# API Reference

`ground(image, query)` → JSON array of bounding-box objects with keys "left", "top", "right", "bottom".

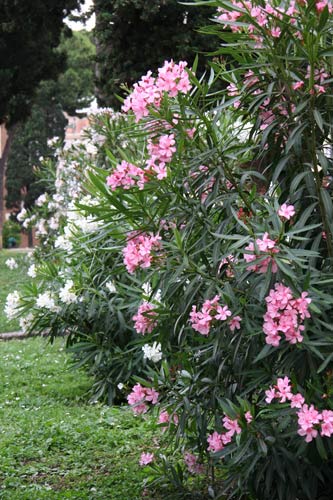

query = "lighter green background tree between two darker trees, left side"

[{"left": 6, "top": 31, "right": 95, "bottom": 208}]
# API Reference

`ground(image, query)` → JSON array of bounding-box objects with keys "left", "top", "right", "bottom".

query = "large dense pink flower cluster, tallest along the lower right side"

[{"left": 263, "top": 283, "right": 311, "bottom": 347}]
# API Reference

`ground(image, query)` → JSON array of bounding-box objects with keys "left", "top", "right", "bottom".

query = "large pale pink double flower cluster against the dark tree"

[{"left": 123, "top": 60, "right": 191, "bottom": 121}]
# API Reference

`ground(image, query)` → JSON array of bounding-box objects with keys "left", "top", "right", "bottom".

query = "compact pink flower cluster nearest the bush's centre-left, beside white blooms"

[{"left": 123, "top": 233, "right": 161, "bottom": 274}]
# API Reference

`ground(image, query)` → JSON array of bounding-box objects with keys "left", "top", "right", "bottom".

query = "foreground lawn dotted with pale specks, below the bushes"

[{"left": 0, "top": 338, "right": 157, "bottom": 500}]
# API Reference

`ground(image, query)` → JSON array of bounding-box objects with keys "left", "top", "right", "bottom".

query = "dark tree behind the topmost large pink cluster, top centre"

[{"left": 94, "top": 0, "right": 215, "bottom": 106}]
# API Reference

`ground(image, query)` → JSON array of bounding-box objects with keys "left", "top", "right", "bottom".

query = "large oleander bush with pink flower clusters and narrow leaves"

[{"left": 5, "top": 0, "right": 333, "bottom": 500}]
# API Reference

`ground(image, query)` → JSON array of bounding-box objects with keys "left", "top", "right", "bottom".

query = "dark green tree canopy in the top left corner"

[{"left": 0, "top": 0, "right": 83, "bottom": 124}]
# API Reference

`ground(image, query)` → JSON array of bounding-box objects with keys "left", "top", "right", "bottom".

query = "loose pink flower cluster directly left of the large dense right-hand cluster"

[{"left": 190, "top": 295, "right": 241, "bottom": 335}]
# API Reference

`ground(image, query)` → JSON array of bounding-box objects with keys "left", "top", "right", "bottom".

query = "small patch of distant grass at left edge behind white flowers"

[{"left": 0, "top": 250, "right": 31, "bottom": 333}]
